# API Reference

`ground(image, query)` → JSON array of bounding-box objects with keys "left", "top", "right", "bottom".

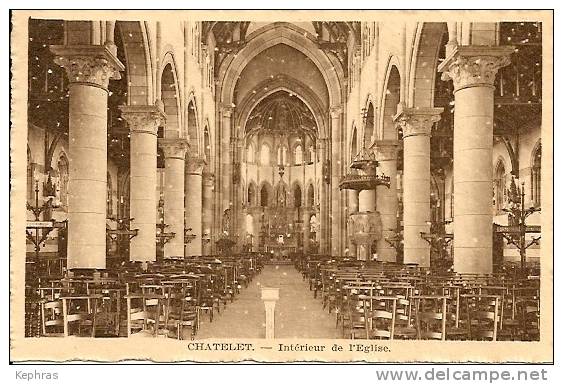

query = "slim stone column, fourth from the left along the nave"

[{"left": 184, "top": 157, "right": 205, "bottom": 257}]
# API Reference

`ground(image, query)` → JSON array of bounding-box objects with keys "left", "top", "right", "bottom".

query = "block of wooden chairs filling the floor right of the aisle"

[{"left": 298, "top": 257, "right": 540, "bottom": 340}]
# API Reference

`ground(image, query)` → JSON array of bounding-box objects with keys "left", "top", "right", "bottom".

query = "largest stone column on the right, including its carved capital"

[{"left": 439, "top": 46, "right": 514, "bottom": 273}]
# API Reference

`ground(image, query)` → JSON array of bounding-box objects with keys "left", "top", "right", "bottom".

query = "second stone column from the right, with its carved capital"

[{"left": 394, "top": 104, "right": 443, "bottom": 267}]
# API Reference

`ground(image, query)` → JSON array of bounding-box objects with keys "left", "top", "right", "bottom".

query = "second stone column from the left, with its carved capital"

[{"left": 120, "top": 105, "right": 165, "bottom": 262}]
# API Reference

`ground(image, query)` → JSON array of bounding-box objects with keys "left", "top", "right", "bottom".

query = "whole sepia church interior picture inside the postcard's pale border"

[{"left": 20, "top": 12, "right": 552, "bottom": 343}]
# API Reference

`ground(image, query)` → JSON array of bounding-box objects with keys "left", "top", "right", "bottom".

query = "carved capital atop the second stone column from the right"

[{"left": 393, "top": 104, "right": 444, "bottom": 138}]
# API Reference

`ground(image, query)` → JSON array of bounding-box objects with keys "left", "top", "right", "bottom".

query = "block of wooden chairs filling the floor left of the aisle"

[{"left": 32, "top": 255, "right": 262, "bottom": 339}]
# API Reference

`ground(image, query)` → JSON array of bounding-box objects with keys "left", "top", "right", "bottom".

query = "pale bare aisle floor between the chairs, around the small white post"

[{"left": 196, "top": 265, "right": 341, "bottom": 339}]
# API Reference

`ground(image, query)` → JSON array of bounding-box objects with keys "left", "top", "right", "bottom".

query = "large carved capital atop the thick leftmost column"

[{"left": 50, "top": 45, "right": 125, "bottom": 91}]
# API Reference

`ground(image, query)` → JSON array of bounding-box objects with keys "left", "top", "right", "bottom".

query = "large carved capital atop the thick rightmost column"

[{"left": 438, "top": 45, "right": 514, "bottom": 92}]
